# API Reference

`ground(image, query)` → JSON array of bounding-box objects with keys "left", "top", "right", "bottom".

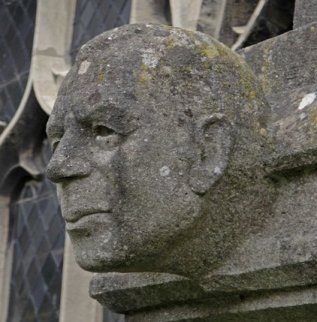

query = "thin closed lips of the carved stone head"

[{"left": 66, "top": 212, "right": 112, "bottom": 231}]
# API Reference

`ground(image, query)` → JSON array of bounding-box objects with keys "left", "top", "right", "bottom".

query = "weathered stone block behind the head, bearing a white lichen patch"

[{"left": 242, "top": 23, "right": 317, "bottom": 171}]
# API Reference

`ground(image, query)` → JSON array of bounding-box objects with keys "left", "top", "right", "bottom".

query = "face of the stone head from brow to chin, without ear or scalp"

[{"left": 48, "top": 78, "right": 200, "bottom": 269}]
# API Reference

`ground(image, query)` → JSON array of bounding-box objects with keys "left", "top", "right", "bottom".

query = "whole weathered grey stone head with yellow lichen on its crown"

[{"left": 47, "top": 25, "right": 271, "bottom": 277}]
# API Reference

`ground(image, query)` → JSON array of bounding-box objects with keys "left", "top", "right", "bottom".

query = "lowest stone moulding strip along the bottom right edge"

[{"left": 126, "top": 288, "right": 317, "bottom": 322}]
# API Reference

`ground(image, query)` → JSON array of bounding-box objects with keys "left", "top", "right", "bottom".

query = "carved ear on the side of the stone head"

[{"left": 189, "top": 113, "right": 233, "bottom": 195}]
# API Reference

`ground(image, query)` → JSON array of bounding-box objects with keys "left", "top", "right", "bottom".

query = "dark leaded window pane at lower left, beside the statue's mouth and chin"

[{"left": 7, "top": 178, "right": 65, "bottom": 322}]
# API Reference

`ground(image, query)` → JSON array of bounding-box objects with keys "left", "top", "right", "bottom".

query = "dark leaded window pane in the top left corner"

[{"left": 0, "top": 0, "right": 36, "bottom": 123}]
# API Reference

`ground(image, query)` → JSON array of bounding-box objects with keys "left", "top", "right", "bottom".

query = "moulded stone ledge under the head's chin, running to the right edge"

[{"left": 90, "top": 273, "right": 317, "bottom": 322}]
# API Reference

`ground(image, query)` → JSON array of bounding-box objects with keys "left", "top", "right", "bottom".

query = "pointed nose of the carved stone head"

[{"left": 46, "top": 139, "right": 91, "bottom": 183}]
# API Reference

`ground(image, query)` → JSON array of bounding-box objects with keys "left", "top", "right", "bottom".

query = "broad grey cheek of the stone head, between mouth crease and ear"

[{"left": 122, "top": 138, "right": 198, "bottom": 231}]
